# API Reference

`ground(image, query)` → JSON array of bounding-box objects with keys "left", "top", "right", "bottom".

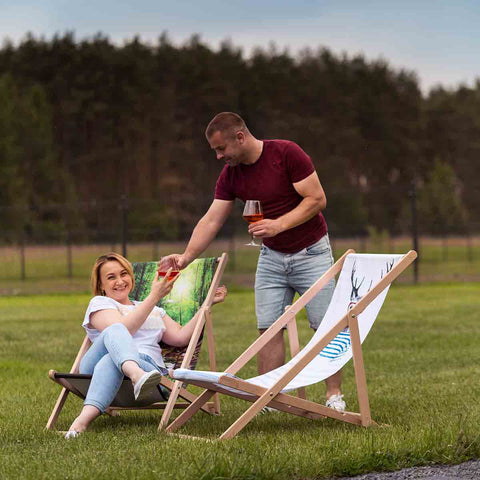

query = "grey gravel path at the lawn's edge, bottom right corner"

[{"left": 336, "top": 460, "right": 480, "bottom": 480}]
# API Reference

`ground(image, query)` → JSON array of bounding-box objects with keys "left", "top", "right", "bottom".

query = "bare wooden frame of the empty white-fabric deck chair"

[{"left": 166, "top": 250, "right": 417, "bottom": 440}]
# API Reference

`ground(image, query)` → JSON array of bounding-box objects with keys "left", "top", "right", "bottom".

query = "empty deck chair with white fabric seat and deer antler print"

[{"left": 166, "top": 250, "right": 417, "bottom": 440}]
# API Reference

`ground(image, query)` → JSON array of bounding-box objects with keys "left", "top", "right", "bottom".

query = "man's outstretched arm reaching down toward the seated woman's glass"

[{"left": 158, "top": 199, "right": 233, "bottom": 270}]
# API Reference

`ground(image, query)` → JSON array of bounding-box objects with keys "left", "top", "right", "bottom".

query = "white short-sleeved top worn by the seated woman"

[{"left": 82, "top": 295, "right": 166, "bottom": 367}]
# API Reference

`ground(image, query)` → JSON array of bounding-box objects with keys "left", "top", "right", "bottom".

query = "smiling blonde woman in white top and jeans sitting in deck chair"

[{"left": 65, "top": 253, "right": 227, "bottom": 438}]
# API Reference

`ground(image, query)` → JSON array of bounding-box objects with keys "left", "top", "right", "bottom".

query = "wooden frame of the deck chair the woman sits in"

[{"left": 46, "top": 253, "right": 228, "bottom": 430}]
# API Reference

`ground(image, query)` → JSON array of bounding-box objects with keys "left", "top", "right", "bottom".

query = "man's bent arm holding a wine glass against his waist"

[{"left": 248, "top": 172, "right": 327, "bottom": 238}]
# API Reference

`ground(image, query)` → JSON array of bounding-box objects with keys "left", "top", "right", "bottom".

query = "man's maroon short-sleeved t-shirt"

[{"left": 215, "top": 140, "right": 327, "bottom": 253}]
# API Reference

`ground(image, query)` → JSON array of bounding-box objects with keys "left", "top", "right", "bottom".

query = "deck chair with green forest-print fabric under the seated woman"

[{"left": 46, "top": 253, "right": 228, "bottom": 429}]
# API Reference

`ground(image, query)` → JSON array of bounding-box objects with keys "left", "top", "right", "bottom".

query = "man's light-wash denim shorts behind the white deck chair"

[{"left": 255, "top": 234, "right": 335, "bottom": 330}]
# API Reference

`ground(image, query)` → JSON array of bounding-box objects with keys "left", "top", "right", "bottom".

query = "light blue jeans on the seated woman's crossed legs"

[{"left": 80, "top": 323, "right": 160, "bottom": 413}]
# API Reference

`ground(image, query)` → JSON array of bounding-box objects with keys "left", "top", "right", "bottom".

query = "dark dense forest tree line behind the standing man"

[{"left": 0, "top": 33, "right": 480, "bottom": 241}]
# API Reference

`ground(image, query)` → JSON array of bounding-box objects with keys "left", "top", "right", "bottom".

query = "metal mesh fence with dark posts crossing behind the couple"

[{"left": 0, "top": 197, "right": 480, "bottom": 292}]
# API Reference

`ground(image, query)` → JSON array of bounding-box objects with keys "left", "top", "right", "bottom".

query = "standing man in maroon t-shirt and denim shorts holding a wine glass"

[{"left": 159, "top": 112, "right": 345, "bottom": 411}]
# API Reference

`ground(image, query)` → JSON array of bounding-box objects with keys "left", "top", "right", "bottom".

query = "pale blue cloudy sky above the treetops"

[{"left": 0, "top": 0, "right": 480, "bottom": 93}]
